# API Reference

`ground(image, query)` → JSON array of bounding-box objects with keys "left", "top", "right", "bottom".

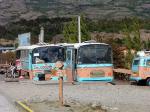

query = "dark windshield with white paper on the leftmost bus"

[{"left": 32, "top": 46, "right": 64, "bottom": 64}]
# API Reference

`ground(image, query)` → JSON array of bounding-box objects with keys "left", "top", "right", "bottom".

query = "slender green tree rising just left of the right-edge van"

[{"left": 123, "top": 18, "right": 143, "bottom": 69}]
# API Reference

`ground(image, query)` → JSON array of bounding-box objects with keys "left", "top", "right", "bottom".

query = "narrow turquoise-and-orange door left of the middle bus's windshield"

[{"left": 66, "top": 48, "right": 76, "bottom": 82}]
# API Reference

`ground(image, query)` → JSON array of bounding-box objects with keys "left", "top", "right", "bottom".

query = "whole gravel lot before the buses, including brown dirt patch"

[{"left": 0, "top": 74, "right": 150, "bottom": 112}]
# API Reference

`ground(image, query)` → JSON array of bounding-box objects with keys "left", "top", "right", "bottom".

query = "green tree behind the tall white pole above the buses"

[{"left": 63, "top": 16, "right": 90, "bottom": 43}]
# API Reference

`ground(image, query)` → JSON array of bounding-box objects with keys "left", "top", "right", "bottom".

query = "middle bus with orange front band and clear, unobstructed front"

[{"left": 63, "top": 42, "right": 113, "bottom": 82}]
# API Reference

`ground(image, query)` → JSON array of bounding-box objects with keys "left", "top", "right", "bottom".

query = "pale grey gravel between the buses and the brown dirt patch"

[{"left": 0, "top": 75, "right": 150, "bottom": 112}]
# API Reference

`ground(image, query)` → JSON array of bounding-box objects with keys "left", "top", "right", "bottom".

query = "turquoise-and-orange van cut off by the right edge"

[{"left": 130, "top": 51, "right": 150, "bottom": 86}]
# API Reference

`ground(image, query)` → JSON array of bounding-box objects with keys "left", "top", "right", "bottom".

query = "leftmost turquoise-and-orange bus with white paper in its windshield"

[{"left": 16, "top": 44, "right": 65, "bottom": 80}]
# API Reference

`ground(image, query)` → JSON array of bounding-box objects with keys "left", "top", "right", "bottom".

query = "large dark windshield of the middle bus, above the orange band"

[{"left": 78, "top": 44, "right": 112, "bottom": 64}]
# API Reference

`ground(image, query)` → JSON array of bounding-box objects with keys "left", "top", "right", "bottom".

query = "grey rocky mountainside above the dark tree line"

[{"left": 0, "top": 0, "right": 150, "bottom": 25}]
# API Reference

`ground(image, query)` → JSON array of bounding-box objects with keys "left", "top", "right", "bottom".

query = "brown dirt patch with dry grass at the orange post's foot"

[{"left": 27, "top": 101, "right": 107, "bottom": 112}]
